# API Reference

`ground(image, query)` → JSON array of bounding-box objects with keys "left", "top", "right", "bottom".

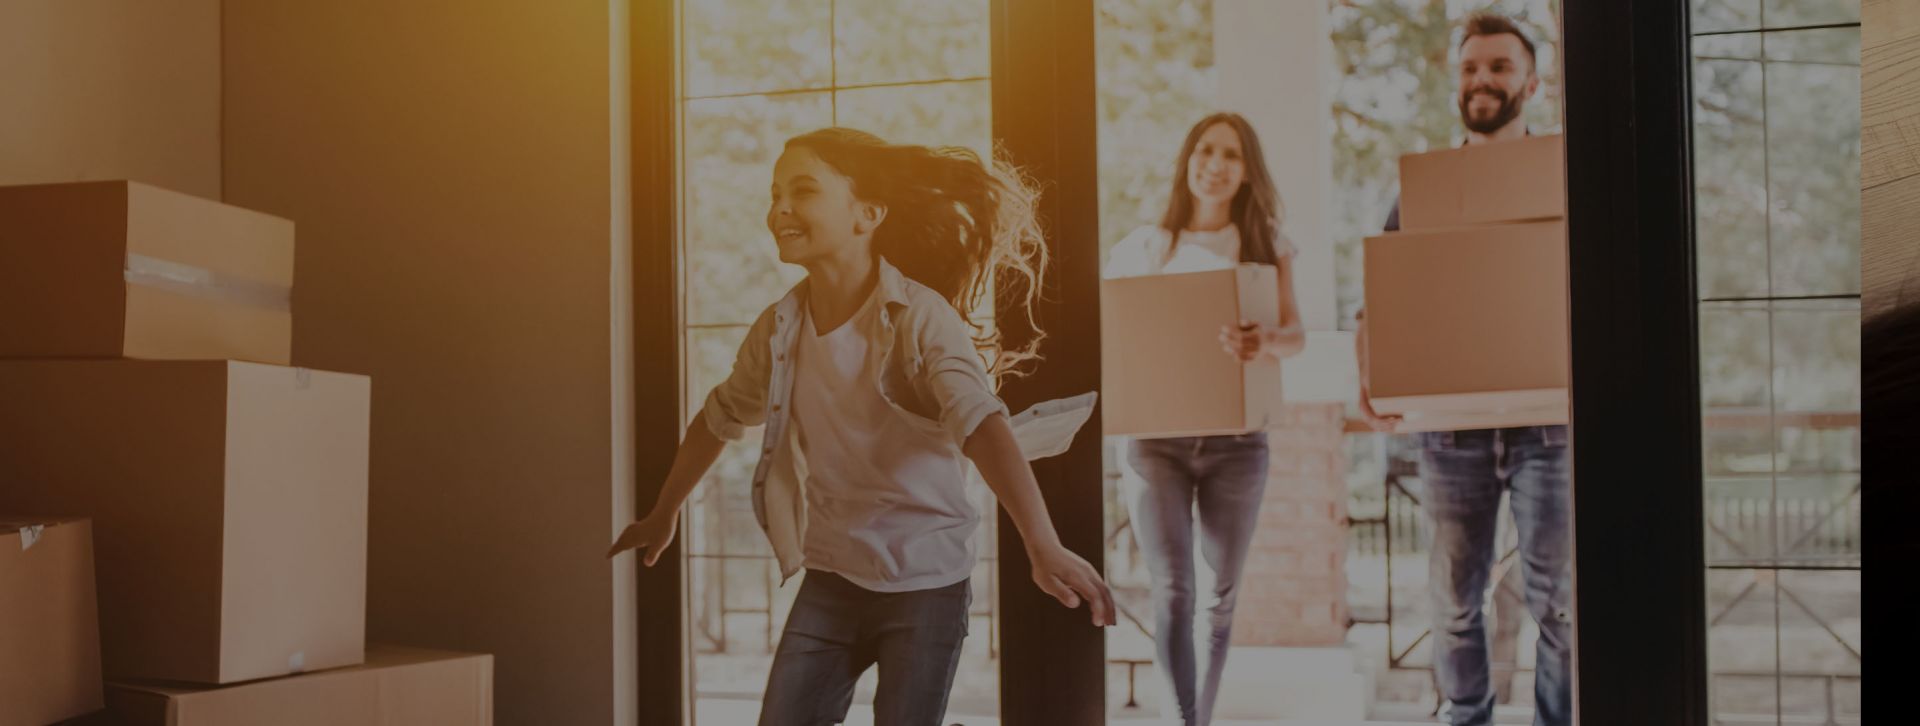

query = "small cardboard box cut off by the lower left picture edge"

[{"left": 0, "top": 514, "right": 102, "bottom": 726}]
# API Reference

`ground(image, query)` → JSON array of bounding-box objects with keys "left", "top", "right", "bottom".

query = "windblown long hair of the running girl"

[{"left": 787, "top": 127, "right": 1046, "bottom": 380}]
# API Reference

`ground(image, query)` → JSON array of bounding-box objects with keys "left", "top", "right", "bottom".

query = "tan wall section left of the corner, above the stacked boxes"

[{"left": 0, "top": 0, "right": 221, "bottom": 200}]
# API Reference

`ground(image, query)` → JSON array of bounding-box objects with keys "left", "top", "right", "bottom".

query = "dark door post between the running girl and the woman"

[{"left": 993, "top": 0, "right": 1106, "bottom": 726}]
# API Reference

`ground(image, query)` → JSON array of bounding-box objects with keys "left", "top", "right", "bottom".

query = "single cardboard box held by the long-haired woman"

[{"left": 1100, "top": 265, "right": 1281, "bottom": 438}]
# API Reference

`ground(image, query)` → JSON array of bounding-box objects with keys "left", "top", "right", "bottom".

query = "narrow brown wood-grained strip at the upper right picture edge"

[{"left": 1860, "top": 0, "right": 1920, "bottom": 315}]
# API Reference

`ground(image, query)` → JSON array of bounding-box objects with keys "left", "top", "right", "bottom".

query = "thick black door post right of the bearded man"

[{"left": 1563, "top": 0, "right": 1707, "bottom": 726}]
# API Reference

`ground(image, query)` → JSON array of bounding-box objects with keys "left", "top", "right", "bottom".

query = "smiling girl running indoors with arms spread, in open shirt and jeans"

[{"left": 614, "top": 129, "right": 1114, "bottom": 726}]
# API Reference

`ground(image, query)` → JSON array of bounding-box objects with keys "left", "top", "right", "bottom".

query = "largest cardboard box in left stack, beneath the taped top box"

[{"left": 0, "top": 359, "right": 371, "bottom": 684}]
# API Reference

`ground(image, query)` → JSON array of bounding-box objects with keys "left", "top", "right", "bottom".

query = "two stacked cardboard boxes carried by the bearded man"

[{"left": 1365, "top": 136, "right": 1569, "bottom": 430}]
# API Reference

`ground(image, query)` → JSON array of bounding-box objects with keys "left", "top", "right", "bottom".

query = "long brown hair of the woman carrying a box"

[{"left": 1160, "top": 111, "right": 1284, "bottom": 265}]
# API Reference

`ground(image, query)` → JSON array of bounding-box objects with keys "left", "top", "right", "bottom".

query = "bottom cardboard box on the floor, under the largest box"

[{"left": 108, "top": 645, "right": 493, "bottom": 726}]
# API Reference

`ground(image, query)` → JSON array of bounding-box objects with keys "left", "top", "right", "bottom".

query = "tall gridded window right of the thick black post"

[{"left": 1693, "top": 9, "right": 1860, "bottom": 724}]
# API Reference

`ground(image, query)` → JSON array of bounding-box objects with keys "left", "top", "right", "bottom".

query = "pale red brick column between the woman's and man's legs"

[{"left": 1233, "top": 403, "right": 1348, "bottom": 647}]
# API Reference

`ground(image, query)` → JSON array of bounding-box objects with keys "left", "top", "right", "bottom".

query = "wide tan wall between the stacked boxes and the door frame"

[{"left": 223, "top": 0, "right": 629, "bottom": 724}]
